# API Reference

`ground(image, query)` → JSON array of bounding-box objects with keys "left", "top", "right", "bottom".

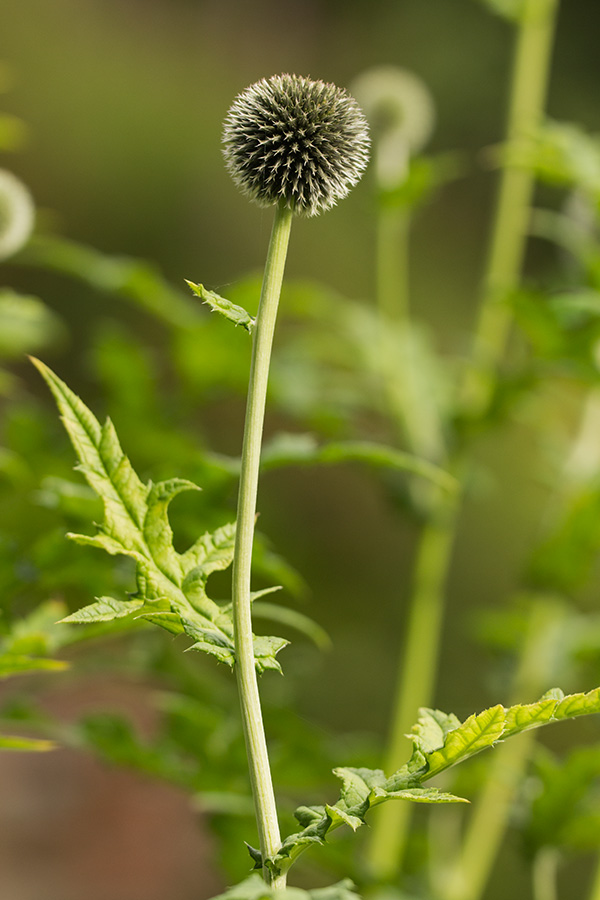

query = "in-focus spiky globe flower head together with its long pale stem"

[{"left": 223, "top": 75, "right": 369, "bottom": 886}]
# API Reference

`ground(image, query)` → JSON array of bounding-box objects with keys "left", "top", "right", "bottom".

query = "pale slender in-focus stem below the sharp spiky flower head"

[{"left": 233, "top": 206, "right": 292, "bottom": 887}]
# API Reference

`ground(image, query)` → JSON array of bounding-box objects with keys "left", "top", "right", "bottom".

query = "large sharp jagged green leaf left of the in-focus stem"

[{"left": 34, "top": 360, "right": 288, "bottom": 672}]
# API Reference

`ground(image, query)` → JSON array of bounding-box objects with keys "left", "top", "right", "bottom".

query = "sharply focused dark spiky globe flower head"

[{"left": 223, "top": 75, "right": 370, "bottom": 216}]
